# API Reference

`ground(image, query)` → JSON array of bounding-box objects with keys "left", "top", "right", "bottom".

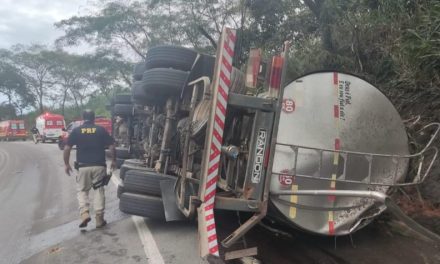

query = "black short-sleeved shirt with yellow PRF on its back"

[{"left": 67, "top": 122, "right": 114, "bottom": 166}]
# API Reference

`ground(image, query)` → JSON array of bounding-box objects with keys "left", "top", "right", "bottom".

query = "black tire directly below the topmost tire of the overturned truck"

[{"left": 142, "top": 68, "right": 189, "bottom": 96}]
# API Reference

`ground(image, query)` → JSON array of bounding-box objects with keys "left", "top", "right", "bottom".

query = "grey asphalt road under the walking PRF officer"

[{"left": 0, "top": 141, "right": 201, "bottom": 264}]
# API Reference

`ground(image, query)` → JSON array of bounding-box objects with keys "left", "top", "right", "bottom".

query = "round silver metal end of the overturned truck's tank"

[{"left": 270, "top": 72, "right": 409, "bottom": 235}]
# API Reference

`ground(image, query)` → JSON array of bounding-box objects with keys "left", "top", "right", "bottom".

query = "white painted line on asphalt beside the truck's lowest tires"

[{"left": 111, "top": 173, "right": 165, "bottom": 264}]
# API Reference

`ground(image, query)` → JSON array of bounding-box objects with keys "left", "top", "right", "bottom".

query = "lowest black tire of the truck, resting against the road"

[{"left": 119, "top": 192, "right": 165, "bottom": 220}]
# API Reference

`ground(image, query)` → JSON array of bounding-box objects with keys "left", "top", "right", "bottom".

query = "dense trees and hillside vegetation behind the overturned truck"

[{"left": 0, "top": 0, "right": 440, "bottom": 122}]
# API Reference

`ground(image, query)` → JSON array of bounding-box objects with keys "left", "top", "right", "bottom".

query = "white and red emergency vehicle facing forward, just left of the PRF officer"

[{"left": 35, "top": 112, "right": 66, "bottom": 143}]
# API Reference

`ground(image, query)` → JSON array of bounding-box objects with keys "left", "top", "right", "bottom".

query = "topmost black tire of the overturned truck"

[{"left": 145, "top": 46, "right": 197, "bottom": 71}]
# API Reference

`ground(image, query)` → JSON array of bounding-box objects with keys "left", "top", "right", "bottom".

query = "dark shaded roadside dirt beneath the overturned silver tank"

[{"left": 217, "top": 211, "right": 440, "bottom": 264}]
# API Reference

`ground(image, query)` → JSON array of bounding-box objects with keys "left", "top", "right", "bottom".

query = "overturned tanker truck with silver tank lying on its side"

[{"left": 112, "top": 28, "right": 439, "bottom": 256}]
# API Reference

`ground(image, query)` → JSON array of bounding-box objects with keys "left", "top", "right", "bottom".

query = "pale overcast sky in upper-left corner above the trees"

[{"left": 0, "top": 0, "right": 90, "bottom": 48}]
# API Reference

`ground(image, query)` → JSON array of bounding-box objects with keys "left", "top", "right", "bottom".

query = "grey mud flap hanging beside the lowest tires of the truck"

[{"left": 159, "top": 180, "right": 186, "bottom": 222}]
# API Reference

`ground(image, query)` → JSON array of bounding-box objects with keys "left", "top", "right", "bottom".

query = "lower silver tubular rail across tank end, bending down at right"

[{"left": 270, "top": 190, "right": 440, "bottom": 244}]
